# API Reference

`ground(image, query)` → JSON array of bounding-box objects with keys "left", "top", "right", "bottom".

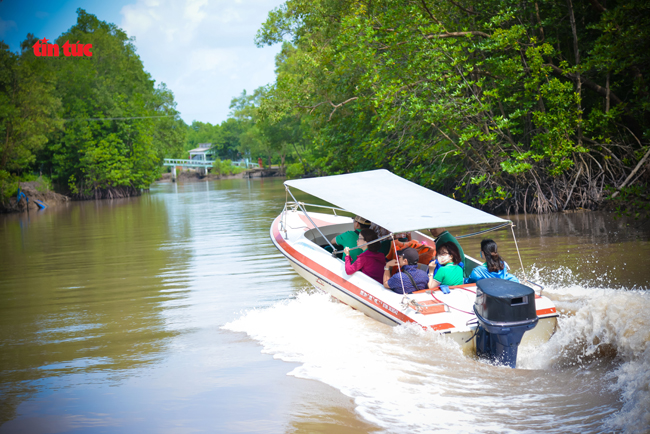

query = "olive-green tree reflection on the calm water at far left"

[{"left": 0, "top": 197, "right": 184, "bottom": 421}]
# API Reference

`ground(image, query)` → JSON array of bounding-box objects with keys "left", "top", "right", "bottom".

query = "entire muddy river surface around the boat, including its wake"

[{"left": 0, "top": 179, "right": 650, "bottom": 434}]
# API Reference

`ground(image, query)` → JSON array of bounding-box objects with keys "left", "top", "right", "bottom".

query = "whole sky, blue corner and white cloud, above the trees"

[{"left": 0, "top": 0, "right": 284, "bottom": 124}]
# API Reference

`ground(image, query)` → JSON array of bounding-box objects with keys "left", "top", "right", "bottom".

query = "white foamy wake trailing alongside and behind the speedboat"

[{"left": 223, "top": 276, "right": 650, "bottom": 433}]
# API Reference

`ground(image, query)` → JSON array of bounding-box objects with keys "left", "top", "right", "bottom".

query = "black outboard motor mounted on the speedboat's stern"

[{"left": 474, "top": 279, "right": 538, "bottom": 368}]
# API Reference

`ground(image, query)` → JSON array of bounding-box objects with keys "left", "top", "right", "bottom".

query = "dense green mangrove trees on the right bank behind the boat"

[{"left": 239, "top": 0, "right": 650, "bottom": 219}]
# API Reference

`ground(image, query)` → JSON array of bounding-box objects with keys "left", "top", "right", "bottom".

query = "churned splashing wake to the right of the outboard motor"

[{"left": 529, "top": 269, "right": 650, "bottom": 433}]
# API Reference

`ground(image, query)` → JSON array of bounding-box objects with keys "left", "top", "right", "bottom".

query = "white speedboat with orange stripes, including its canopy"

[{"left": 270, "top": 170, "right": 558, "bottom": 367}]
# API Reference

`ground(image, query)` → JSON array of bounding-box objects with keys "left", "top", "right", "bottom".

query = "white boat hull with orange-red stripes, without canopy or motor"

[{"left": 270, "top": 210, "right": 558, "bottom": 354}]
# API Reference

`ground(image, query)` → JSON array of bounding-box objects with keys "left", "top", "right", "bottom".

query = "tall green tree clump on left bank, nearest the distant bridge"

[{"left": 43, "top": 9, "right": 186, "bottom": 197}]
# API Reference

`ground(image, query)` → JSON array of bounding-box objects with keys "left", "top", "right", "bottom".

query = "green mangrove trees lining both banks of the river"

[{"left": 0, "top": 0, "right": 650, "bottom": 217}]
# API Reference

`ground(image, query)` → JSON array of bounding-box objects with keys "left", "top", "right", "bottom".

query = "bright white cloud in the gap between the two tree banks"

[{"left": 121, "top": 0, "right": 283, "bottom": 124}]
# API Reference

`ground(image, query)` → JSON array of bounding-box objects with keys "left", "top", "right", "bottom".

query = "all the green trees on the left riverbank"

[{"left": 0, "top": 9, "right": 187, "bottom": 201}]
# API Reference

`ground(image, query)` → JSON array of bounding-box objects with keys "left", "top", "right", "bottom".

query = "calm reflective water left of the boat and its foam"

[{"left": 0, "top": 180, "right": 360, "bottom": 433}]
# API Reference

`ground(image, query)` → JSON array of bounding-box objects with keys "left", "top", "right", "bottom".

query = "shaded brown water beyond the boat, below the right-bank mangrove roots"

[{"left": 450, "top": 212, "right": 650, "bottom": 289}]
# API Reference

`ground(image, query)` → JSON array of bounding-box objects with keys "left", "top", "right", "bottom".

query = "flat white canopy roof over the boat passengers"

[{"left": 284, "top": 169, "right": 510, "bottom": 233}]
